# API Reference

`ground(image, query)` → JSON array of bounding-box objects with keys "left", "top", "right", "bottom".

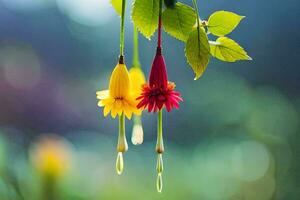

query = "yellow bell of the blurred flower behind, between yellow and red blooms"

[{"left": 129, "top": 67, "right": 146, "bottom": 98}]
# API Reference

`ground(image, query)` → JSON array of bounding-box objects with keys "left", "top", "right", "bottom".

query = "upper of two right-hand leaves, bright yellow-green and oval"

[{"left": 208, "top": 11, "right": 244, "bottom": 36}]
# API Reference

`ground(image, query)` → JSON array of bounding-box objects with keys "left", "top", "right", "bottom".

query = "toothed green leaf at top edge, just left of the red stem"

[{"left": 132, "top": 0, "right": 159, "bottom": 39}]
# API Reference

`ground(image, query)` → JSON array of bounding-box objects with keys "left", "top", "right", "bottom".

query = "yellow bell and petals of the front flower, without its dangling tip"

[{"left": 96, "top": 64, "right": 141, "bottom": 119}]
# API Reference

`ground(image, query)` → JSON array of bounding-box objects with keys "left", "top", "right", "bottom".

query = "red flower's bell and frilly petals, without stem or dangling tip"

[{"left": 137, "top": 47, "right": 183, "bottom": 112}]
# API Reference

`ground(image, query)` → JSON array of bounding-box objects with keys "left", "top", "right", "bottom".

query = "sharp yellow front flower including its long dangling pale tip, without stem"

[{"left": 96, "top": 55, "right": 142, "bottom": 175}]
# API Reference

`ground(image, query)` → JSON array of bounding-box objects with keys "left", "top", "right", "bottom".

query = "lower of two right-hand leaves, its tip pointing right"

[{"left": 210, "top": 37, "right": 252, "bottom": 62}]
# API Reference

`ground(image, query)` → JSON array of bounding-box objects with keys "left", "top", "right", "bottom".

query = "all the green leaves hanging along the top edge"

[{"left": 111, "top": 0, "right": 251, "bottom": 79}]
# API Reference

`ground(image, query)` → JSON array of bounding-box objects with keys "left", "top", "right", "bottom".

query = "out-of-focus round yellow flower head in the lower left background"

[{"left": 30, "top": 136, "right": 71, "bottom": 177}]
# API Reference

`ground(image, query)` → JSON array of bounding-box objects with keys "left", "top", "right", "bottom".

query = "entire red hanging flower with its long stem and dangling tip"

[{"left": 137, "top": 0, "right": 183, "bottom": 193}]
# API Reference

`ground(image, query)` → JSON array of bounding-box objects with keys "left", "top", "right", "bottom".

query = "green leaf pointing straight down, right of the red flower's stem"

[{"left": 185, "top": 28, "right": 210, "bottom": 80}]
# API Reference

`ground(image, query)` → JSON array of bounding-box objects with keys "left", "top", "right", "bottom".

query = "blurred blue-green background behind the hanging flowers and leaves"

[{"left": 0, "top": 0, "right": 300, "bottom": 200}]
